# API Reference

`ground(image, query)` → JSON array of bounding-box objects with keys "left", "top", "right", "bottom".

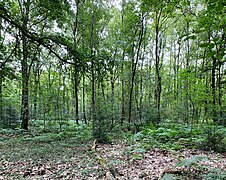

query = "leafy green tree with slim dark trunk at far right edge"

[{"left": 198, "top": 0, "right": 225, "bottom": 123}]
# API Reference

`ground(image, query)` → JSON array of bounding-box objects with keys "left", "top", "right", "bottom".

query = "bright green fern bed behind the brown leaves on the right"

[{"left": 129, "top": 123, "right": 226, "bottom": 152}]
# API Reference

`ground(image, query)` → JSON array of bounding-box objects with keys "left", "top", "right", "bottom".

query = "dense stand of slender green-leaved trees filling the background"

[{"left": 0, "top": 0, "right": 225, "bottom": 136}]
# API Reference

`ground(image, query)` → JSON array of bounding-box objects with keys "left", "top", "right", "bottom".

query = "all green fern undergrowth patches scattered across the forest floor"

[{"left": 0, "top": 121, "right": 226, "bottom": 179}]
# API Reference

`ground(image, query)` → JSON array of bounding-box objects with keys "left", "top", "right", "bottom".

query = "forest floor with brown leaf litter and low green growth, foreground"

[{"left": 0, "top": 126, "right": 226, "bottom": 180}]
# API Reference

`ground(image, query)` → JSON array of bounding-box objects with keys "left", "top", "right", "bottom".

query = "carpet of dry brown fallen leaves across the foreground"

[{"left": 0, "top": 142, "right": 226, "bottom": 180}]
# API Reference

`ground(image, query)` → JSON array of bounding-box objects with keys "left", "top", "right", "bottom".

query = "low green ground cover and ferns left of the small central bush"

[{"left": 0, "top": 124, "right": 92, "bottom": 161}]
